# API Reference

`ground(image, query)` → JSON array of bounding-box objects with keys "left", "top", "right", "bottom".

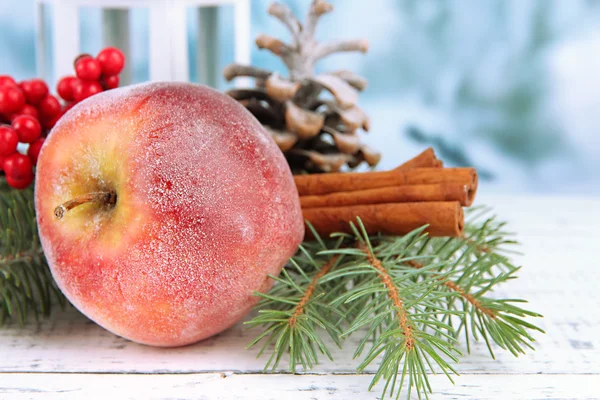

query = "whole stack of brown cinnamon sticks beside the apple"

[{"left": 294, "top": 148, "right": 478, "bottom": 239}]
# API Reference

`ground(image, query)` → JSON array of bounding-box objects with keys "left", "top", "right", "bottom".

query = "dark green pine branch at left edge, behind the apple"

[{"left": 0, "top": 177, "right": 65, "bottom": 325}]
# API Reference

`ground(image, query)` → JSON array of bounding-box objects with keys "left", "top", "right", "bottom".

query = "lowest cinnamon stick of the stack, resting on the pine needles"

[{"left": 302, "top": 201, "right": 464, "bottom": 239}]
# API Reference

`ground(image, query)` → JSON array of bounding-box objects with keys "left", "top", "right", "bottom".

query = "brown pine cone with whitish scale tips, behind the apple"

[{"left": 223, "top": 0, "right": 381, "bottom": 174}]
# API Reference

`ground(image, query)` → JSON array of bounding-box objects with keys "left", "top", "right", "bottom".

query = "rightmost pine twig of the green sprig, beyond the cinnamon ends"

[{"left": 398, "top": 209, "right": 543, "bottom": 358}]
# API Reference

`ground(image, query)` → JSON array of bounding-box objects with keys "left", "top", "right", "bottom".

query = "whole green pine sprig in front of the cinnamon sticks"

[{"left": 247, "top": 209, "right": 543, "bottom": 398}]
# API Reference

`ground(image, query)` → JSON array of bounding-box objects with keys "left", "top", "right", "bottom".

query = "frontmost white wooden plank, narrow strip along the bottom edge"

[{"left": 0, "top": 373, "right": 600, "bottom": 400}]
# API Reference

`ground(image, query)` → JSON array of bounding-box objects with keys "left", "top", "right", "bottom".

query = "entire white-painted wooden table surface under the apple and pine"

[{"left": 0, "top": 196, "right": 600, "bottom": 400}]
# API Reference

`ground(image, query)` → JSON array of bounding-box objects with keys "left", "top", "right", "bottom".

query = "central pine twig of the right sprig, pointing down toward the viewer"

[{"left": 327, "top": 223, "right": 460, "bottom": 398}]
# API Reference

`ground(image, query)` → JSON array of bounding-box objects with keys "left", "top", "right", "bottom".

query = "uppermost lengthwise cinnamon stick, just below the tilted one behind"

[{"left": 294, "top": 168, "right": 477, "bottom": 197}]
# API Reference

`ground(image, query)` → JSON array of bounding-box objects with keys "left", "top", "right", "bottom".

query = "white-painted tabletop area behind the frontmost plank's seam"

[{"left": 0, "top": 197, "right": 600, "bottom": 382}]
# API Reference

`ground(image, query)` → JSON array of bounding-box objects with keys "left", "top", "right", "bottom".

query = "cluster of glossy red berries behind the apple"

[{"left": 0, "top": 47, "right": 125, "bottom": 189}]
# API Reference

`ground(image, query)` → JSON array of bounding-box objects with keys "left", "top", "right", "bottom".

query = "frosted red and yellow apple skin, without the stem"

[{"left": 35, "top": 83, "right": 304, "bottom": 347}]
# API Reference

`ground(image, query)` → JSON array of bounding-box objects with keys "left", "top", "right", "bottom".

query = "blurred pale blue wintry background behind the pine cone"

[{"left": 0, "top": 0, "right": 600, "bottom": 196}]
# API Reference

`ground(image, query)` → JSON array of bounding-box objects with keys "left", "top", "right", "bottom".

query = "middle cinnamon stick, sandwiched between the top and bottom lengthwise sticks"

[{"left": 300, "top": 183, "right": 473, "bottom": 208}]
